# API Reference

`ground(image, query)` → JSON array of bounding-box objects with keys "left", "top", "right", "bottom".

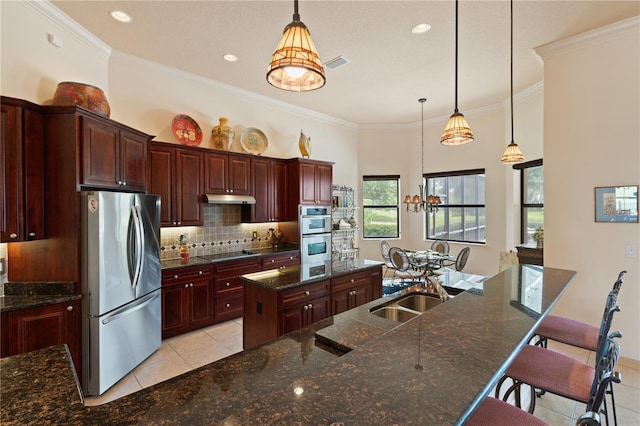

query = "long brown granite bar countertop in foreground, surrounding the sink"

[{"left": 0, "top": 265, "right": 575, "bottom": 425}]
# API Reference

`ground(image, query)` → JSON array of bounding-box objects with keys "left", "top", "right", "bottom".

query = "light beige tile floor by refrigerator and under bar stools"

[{"left": 85, "top": 319, "right": 640, "bottom": 426}]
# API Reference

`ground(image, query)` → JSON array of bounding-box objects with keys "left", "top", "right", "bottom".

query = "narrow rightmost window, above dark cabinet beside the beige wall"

[{"left": 513, "top": 160, "right": 544, "bottom": 244}]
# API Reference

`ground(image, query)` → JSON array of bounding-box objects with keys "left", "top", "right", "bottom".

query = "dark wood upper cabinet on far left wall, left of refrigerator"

[{"left": 0, "top": 96, "right": 45, "bottom": 243}]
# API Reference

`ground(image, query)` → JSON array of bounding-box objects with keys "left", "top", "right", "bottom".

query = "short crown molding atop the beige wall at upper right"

[{"left": 533, "top": 15, "right": 640, "bottom": 60}]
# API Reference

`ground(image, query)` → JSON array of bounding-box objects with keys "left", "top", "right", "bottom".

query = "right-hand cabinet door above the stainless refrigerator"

[{"left": 120, "top": 131, "right": 147, "bottom": 192}]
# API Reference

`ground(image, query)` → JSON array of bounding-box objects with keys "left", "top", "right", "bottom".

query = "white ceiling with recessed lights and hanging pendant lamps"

[{"left": 52, "top": 0, "right": 640, "bottom": 125}]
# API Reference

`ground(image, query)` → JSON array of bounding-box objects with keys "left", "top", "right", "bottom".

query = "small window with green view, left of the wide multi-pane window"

[{"left": 362, "top": 176, "right": 400, "bottom": 238}]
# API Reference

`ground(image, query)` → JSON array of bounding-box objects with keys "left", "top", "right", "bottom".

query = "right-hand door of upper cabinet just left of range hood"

[{"left": 175, "top": 149, "right": 203, "bottom": 226}]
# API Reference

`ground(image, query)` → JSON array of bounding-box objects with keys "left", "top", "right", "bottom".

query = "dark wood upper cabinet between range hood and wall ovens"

[{"left": 242, "top": 158, "right": 287, "bottom": 223}]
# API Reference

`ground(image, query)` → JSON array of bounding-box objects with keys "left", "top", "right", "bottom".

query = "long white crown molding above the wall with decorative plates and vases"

[{"left": 111, "top": 50, "right": 358, "bottom": 129}]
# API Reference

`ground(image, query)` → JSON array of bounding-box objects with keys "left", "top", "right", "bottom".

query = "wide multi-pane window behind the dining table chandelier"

[{"left": 424, "top": 169, "right": 486, "bottom": 243}]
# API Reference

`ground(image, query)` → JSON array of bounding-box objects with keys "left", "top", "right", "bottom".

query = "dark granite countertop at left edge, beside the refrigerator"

[{"left": 0, "top": 282, "right": 81, "bottom": 312}]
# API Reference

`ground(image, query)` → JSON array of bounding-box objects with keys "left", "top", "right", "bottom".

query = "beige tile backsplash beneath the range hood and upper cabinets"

[{"left": 160, "top": 204, "right": 292, "bottom": 260}]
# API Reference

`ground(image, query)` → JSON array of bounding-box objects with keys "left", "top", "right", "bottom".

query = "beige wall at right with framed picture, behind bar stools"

[{"left": 538, "top": 18, "right": 640, "bottom": 359}]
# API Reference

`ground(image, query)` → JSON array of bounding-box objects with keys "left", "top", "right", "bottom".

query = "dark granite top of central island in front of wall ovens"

[{"left": 242, "top": 259, "right": 384, "bottom": 290}]
